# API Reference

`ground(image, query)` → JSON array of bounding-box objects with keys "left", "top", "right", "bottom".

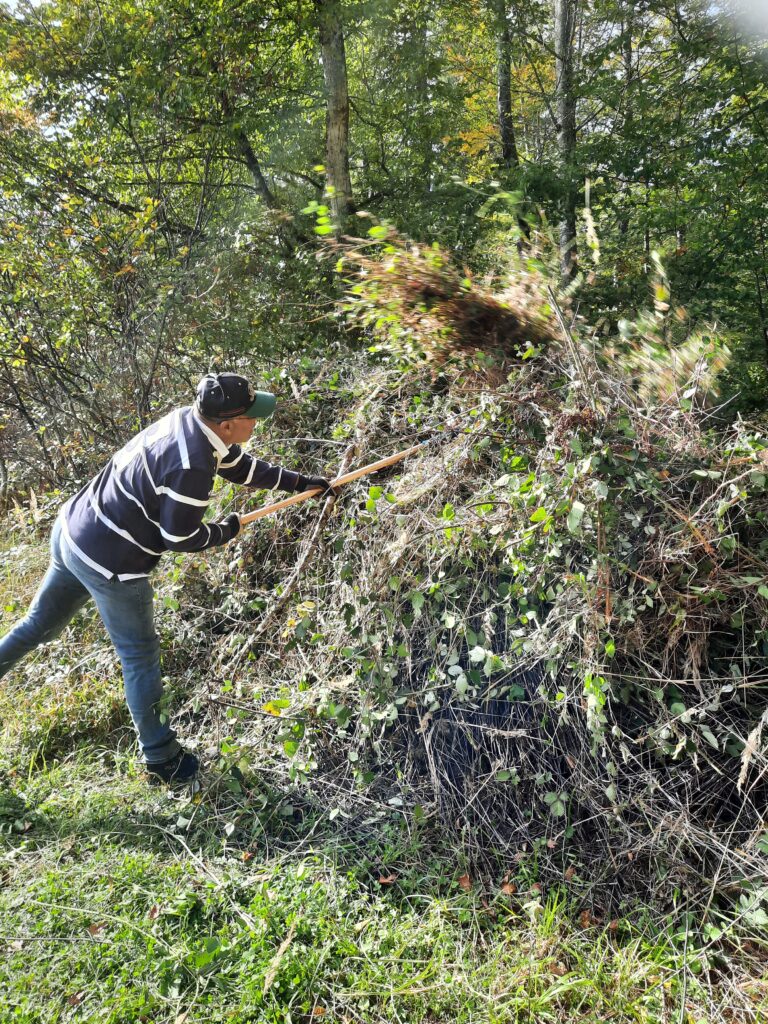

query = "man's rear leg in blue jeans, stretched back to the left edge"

[{"left": 0, "top": 520, "right": 90, "bottom": 678}]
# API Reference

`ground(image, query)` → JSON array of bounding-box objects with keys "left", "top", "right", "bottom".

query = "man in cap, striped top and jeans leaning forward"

[{"left": 0, "top": 374, "right": 330, "bottom": 782}]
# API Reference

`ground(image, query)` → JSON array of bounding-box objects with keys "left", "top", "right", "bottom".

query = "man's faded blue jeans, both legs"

[{"left": 0, "top": 519, "right": 180, "bottom": 764}]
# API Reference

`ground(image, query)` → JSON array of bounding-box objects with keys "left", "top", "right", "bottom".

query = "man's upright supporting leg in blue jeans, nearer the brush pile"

[{"left": 67, "top": 562, "right": 181, "bottom": 764}]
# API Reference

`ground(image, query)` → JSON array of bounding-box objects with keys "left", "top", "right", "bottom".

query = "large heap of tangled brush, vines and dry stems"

[{"left": 199, "top": 230, "right": 768, "bottom": 915}]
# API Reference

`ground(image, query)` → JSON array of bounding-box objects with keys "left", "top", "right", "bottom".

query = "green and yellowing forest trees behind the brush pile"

[{"left": 0, "top": 0, "right": 768, "bottom": 493}]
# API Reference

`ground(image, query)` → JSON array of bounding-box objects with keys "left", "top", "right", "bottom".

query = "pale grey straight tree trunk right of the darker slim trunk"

[{"left": 555, "top": 0, "right": 579, "bottom": 285}]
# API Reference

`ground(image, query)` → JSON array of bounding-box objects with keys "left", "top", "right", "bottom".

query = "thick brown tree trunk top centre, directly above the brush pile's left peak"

[{"left": 315, "top": 0, "right": 352, "bottom": 231}]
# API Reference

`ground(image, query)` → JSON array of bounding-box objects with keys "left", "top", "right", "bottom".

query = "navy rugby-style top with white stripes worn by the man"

[{"left": 62, "top": 408, "right": 301, "bottom": 580}]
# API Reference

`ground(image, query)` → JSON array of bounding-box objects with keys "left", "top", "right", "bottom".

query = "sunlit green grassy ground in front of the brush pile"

[{"left": 0, "top": 544, "right": 768, "bottom": 1024}]
